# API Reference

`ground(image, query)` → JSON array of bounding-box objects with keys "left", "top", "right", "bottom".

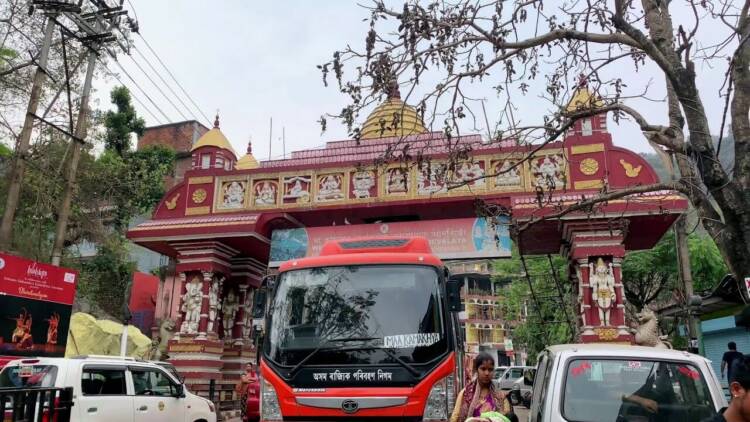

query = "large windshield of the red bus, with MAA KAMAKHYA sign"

[{"left": 267, "top": 265, "right": 448, "bottom": 365}]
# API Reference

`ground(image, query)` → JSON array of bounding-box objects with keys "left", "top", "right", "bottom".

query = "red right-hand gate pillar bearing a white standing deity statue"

[{"left": 565, "top": 225, "right": 632, "bottom": 343}]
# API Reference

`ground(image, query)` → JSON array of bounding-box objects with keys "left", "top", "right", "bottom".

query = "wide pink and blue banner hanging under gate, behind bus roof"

[{"left": 269, "top": 218, "right": 511, "bottom": 267}]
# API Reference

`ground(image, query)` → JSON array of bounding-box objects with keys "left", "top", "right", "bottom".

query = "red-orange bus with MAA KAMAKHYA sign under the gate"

[{"left": 260, "top": 237, "right": 463, "bottom": 422}]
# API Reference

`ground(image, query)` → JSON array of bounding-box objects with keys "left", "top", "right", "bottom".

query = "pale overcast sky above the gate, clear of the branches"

[{"left": 96, "top": 0, "right": 736, "bottom": 160}]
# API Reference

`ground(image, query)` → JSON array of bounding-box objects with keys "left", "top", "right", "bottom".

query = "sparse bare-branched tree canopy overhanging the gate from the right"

[{"left": 330, "top": 0, "right": 750, "bottom": 300}]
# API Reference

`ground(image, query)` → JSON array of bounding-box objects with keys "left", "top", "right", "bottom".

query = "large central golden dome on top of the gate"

[{"left": 361, "top": 83, "right": 427, "bottom": 139}]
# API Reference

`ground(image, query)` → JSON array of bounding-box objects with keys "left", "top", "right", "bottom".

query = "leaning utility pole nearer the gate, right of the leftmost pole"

[{"left": 52, "top": 39, "right": 96, "bottom": 266}]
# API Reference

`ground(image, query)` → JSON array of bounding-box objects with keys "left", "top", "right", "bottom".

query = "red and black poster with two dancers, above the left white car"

[{"left": 0, "top": 253, "right": 78, "bottom": 356}]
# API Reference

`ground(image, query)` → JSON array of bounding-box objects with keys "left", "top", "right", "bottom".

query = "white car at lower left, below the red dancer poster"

[{"left": 0, "top": 356, "right": 216, "bottom": 422}]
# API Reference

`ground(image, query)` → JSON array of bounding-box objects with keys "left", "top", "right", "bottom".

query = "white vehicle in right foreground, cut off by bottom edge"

[{"left": 529, "top": 344, "right": 727, "bottom": 422}]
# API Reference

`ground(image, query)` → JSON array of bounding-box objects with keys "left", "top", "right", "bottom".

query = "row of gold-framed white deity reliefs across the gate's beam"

[{"left": 207, "top": 149, "right": 570, "bottom": 212}]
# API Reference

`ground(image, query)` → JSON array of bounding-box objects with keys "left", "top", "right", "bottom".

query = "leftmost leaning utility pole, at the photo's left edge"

[{"left": 0, "top": 13, "right": 56, "bottom": 251}]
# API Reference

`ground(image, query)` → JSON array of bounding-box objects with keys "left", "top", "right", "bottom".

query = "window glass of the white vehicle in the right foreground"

[{"left": 562, "top": 359, "right": 715, "bottom": 422}]
